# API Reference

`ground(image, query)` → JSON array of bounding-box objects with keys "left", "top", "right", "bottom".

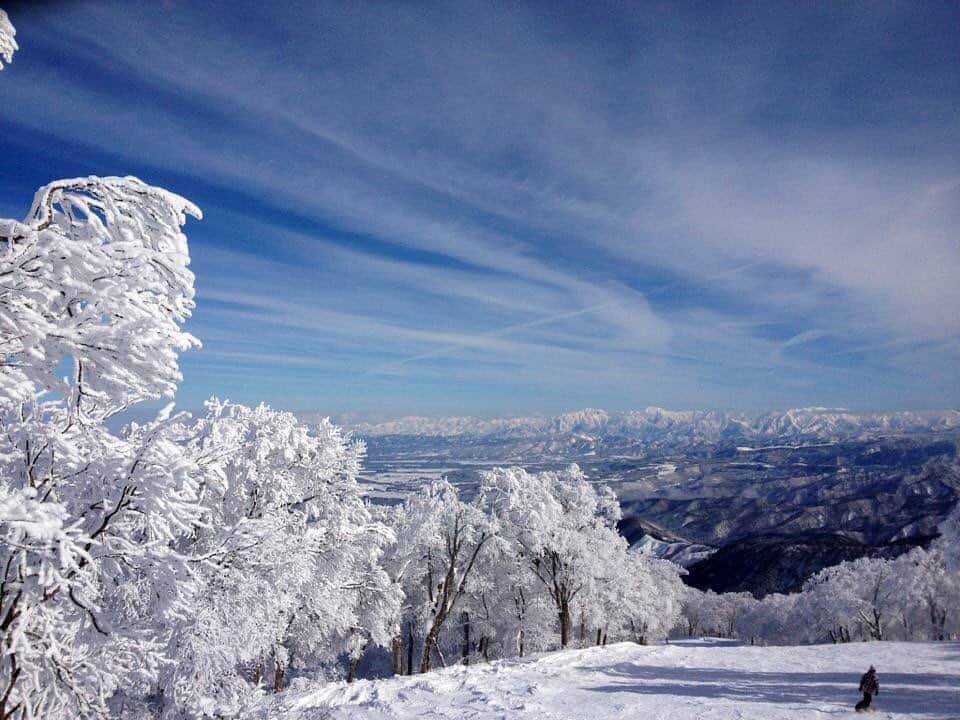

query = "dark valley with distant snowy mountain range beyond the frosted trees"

[{"left": 355, "top": 408, "right": 960, "bottom": 596}]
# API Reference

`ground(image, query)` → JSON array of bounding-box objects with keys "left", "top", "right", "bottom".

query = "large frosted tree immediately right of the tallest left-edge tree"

[{"left": 166, "top": 400, "right": 399, "bottom": 715}]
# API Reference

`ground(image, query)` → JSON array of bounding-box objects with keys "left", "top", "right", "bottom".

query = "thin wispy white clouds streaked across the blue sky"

[{"left": 0, "top": 3, "right": 960, "bottom": 406}]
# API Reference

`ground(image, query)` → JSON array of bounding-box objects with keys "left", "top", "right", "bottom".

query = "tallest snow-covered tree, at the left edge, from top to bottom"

[{"left": 0, "top": 177, "right": 200, "bottom": 718}]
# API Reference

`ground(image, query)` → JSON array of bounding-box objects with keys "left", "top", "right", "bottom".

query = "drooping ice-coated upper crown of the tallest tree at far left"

[{"left": 0, "top": 177, "right": 200, "bottom": 422}]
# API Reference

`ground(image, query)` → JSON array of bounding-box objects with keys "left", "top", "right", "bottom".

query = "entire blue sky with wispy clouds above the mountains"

[{"left": 0, "top": 0, "right": 960, "bottom": 417}]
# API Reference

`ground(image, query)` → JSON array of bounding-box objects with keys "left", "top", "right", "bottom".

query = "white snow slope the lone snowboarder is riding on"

[{"left": 246, "top": 640, "right": 960, "bottom": 720}]
